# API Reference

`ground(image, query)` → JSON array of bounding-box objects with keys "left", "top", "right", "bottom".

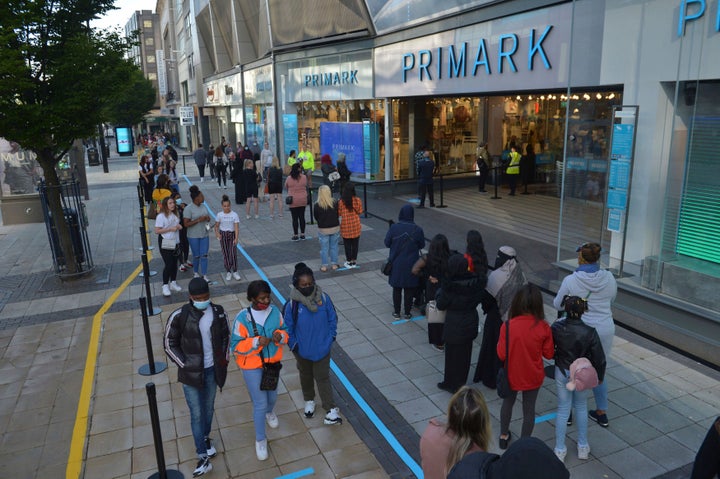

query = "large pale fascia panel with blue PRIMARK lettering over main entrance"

[{"left": 374, "top": 2, "right": 604, "bottom": 97}]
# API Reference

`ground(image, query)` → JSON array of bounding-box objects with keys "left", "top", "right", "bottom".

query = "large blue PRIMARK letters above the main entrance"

[{"left": 402, "top": 25, "right": 553, "bottom": 83}]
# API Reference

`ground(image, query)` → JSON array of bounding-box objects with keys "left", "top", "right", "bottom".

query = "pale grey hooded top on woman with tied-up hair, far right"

[{"left": 553, "top": 269, "right": 617, "bottom": 336}]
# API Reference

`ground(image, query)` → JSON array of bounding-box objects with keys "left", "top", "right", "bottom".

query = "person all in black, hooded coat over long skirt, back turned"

[{"left": 436, "top": 254, "right": 482, "bottom": 394}]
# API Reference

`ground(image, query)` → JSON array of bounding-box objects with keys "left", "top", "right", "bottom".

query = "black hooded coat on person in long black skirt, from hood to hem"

[{"left": 436, "top": 254, "right": 483, "bottom": 344}]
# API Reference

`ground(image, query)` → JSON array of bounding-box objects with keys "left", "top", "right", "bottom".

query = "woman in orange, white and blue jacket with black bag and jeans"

[{"left": 230, "top": 280, "right": 288, "bottom": 461}]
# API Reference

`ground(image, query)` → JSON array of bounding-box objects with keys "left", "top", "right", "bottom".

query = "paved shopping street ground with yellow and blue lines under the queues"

[{"left": 0, "top": 148, "right": 720, "bottom": 479}]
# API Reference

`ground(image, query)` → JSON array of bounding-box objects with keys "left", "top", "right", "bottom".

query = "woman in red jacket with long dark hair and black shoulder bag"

[{"left": 497, "top": 284, "right": 555, "bottom": 449}]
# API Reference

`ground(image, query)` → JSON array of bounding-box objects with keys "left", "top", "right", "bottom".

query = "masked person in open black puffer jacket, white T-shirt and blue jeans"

[{"left": 164, "top": 278, "right": 230, "bottom": 476}]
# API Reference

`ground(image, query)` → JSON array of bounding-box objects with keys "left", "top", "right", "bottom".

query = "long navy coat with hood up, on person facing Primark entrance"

[{"left": 385, "top": 205, "right": 425, "bottom": 288}]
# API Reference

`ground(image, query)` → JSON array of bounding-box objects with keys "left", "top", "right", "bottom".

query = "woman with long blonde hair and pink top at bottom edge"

[{"left": 420, "top": 386, "right": 492, "bottom": 479}]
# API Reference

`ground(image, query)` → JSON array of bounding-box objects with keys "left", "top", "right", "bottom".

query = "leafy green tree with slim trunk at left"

[{"left": 0, "top": 0, "right": 154, "bottom": 274}]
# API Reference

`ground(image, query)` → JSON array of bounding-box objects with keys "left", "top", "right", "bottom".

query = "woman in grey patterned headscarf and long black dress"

[{"left": 473, "top": 246, "right": 525, "bottom": 389}]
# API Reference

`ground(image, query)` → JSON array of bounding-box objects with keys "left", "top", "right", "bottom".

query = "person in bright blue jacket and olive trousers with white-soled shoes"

[{"left": 283, "top": 263, "right": 342, "bottom": 425}]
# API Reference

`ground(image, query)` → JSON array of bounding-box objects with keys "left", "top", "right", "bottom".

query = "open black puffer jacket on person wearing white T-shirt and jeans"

[{"left": 163, "top": 303, "right": 230, "bottom": 389}]
